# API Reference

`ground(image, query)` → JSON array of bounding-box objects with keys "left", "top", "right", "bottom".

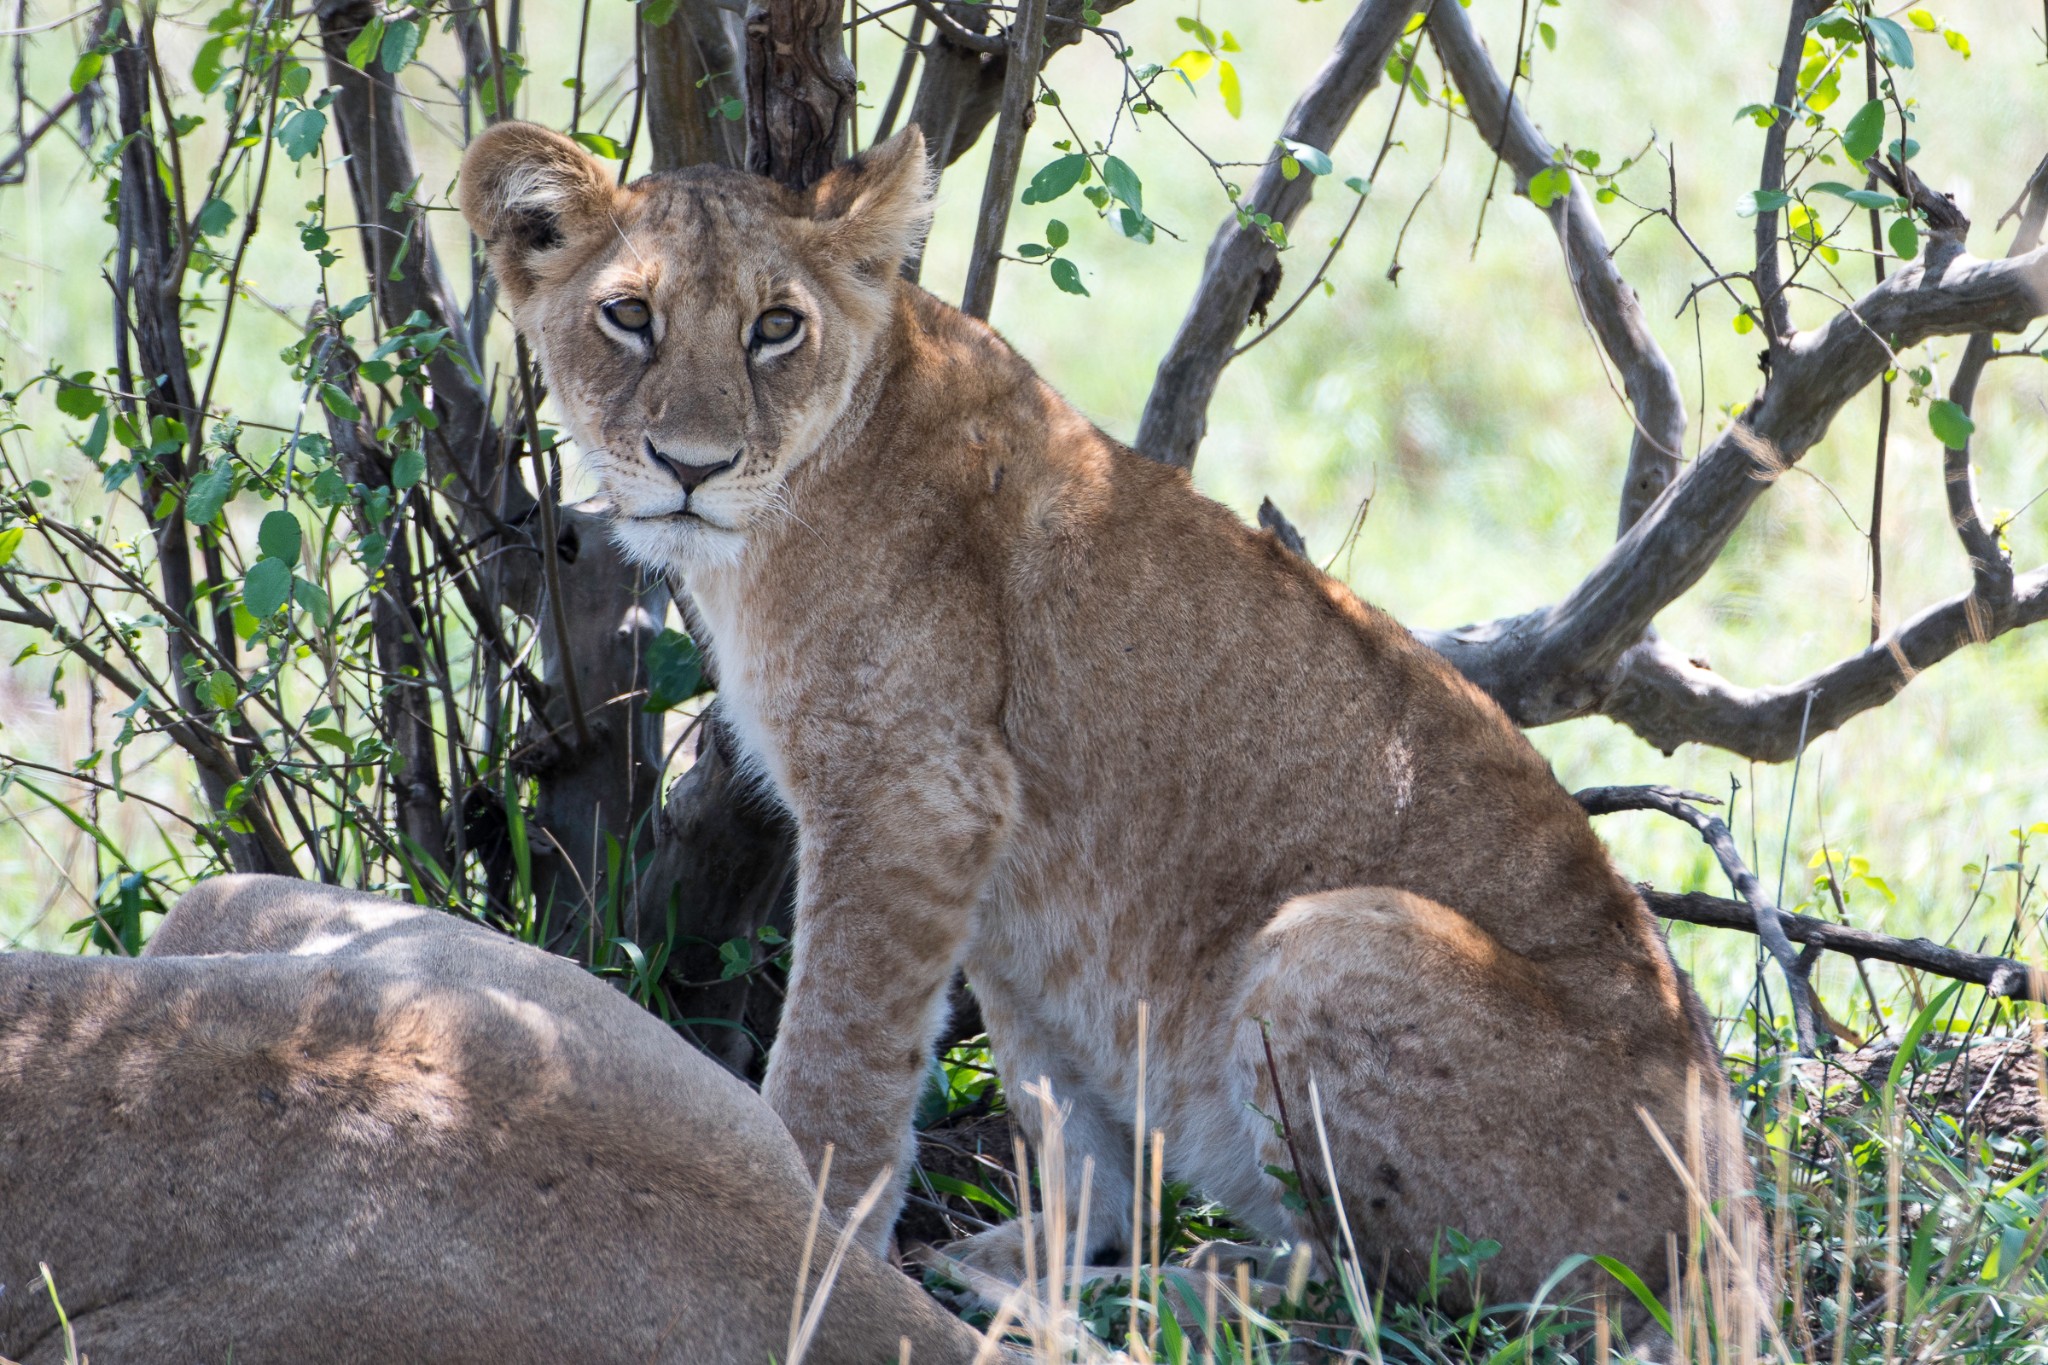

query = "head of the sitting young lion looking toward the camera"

[{"left": 461, "top": 123, "right": 932, "bottom": 567}]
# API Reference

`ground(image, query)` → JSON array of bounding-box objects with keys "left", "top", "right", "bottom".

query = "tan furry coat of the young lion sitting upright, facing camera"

[{"left": 463, "top": 127, "right": 1745, "bottom": 1297}]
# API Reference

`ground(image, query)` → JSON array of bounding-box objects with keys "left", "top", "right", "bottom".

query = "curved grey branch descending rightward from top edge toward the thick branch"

[{"left": 1430, "top": 4, "right": 1686, "bottom": 532}]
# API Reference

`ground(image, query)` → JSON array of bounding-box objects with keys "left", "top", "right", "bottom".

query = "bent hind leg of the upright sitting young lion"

[{"left": 1219, "top": 886, "right": 1686, "bottom": 1334}]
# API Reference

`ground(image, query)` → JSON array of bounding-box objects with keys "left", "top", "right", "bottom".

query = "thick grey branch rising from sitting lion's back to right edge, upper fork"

[{"left": 1417, "top": 248, "right": 2048, "bottom": 739}]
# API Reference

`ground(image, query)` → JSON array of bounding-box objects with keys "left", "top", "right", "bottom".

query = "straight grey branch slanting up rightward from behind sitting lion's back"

[{"left": 1133, "top": 0, "right": 1425, "bottom": 469}]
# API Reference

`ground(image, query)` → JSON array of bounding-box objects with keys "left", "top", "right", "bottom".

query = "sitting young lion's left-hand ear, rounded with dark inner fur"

[{"left": 459, "top": 123, "right": 618, "bottom": 303}]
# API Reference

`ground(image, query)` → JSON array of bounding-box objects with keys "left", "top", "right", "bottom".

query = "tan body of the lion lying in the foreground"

[{"left": 0, "top": 878, "right": 991, "bottom": 1365}]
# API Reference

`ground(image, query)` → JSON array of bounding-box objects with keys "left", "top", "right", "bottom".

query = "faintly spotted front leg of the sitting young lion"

[{"left": 762, "top": 739, "right": 1014, "bottom": 1248}]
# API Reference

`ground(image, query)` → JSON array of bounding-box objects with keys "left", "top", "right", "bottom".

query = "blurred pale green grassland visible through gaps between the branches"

[{"left": 0, "top": 0, "right": 2048, "bottom": 1011}]
